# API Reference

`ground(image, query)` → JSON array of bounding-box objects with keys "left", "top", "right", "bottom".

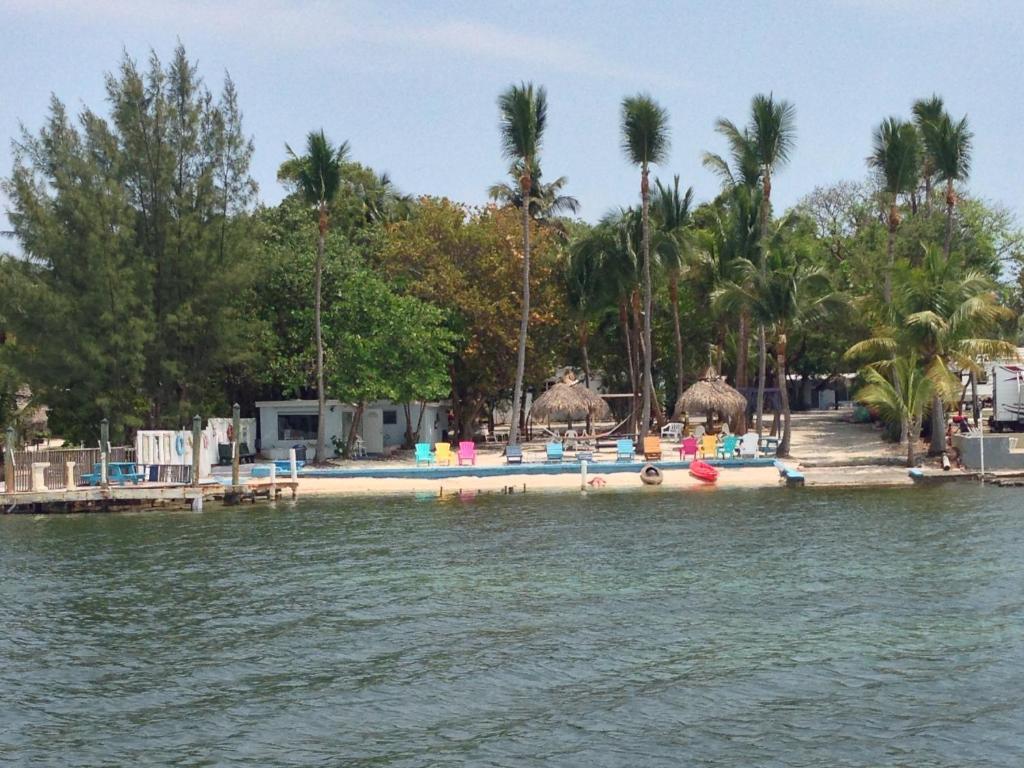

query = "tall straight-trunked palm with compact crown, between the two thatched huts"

[{"left": 622, "top": 94, "right": 669, "bottom": 439}]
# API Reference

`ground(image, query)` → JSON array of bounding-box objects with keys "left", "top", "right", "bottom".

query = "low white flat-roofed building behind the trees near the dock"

[{"left": 256, "top": 400, "right": 449, "bottom": 461}]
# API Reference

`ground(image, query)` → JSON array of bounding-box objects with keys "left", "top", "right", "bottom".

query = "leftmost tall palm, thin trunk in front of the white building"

[{"left": 279, "top": 129, "right": 348, "bottom": 462}]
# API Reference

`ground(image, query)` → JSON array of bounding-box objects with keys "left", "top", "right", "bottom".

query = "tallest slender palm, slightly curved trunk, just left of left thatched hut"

[{"left": 498, "top": 83, "right": 548, "bottom": 445}]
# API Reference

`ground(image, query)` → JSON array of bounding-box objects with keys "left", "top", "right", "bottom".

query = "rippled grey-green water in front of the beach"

[{"left": 0, "top": 485, "right": 1024, "bottom": 768}]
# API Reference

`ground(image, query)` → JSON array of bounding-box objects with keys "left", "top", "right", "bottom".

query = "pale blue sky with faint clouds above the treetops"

[{"left": 0, "top": 0, "right": 1024, "bottom": 237}]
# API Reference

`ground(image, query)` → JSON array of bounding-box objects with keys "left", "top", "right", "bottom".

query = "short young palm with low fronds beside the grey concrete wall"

[{"left": 854, "top": 354, "right": 935, "bottom": 467}]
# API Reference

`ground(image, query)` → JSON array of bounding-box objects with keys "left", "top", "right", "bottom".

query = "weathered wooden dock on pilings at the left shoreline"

[{"left": 0, "top": 479, "right": 299, "bottom": 514}]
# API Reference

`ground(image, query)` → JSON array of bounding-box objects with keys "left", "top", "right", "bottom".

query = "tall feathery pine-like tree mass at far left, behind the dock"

[{"left": 4, "top": 46, "right": 255, "bottom": 440}]
